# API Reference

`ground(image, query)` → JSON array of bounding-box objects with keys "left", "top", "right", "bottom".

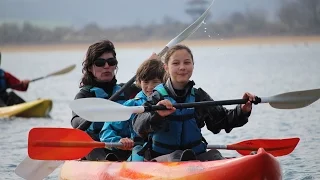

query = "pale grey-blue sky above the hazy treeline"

[{"left": 0, "top": 0, "right": 283, "bottom": 28}]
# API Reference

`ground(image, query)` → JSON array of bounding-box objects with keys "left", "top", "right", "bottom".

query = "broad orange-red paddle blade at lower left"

[{"left": 28, "top": 128, "right": 95, "bottom": 160}]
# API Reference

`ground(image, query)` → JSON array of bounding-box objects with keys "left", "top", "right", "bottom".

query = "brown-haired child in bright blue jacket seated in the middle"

[{"left": 100, "top": 54, "right": 165, "bottom": 161}]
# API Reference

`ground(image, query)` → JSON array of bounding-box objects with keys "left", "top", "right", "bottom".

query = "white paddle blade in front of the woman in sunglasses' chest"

[{"left": 70, "top": 98, "right": 144, "bottom": 122}]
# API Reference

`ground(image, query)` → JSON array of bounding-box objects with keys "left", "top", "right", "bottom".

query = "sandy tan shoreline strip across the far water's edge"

[{"left": 0, "top": 36, "right": 320, "bottom": 53}]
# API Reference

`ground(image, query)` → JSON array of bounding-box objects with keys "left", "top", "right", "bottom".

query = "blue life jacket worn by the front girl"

[{"left": 152, "top": 84, "right": 207, "bottom": 154}]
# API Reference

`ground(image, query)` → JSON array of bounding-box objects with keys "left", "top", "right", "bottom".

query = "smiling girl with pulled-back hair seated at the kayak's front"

[{"left": 133, "top": 45, "right": 255, "bottom": 162}]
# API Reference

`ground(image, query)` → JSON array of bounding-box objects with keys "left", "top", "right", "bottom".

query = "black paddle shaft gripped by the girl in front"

[{"left": 144, "top": 96, "right": 261, "bottom": 111}]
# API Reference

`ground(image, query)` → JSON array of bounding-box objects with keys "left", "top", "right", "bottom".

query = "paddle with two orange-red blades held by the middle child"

[{"left": 28, "top": 128, "right": 299, "bottom": 160}]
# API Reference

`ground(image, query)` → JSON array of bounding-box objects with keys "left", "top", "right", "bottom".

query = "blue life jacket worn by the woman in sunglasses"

[{"left": 82, "top": 85, "right": 125, "bottom": 137}]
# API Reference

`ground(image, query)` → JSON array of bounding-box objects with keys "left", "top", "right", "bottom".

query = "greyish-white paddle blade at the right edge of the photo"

[{"left": 261, "top": 89, "right": 320, "bottom": 109}]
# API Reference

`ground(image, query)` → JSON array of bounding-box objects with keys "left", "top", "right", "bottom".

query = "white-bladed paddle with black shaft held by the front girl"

[{"left": 70, "top": 89, "right": 320, "bottom": 122}]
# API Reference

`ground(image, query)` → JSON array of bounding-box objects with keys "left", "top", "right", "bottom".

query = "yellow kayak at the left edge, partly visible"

[{"left": 0, "top": 99, "right": 52, "bottom": 118}]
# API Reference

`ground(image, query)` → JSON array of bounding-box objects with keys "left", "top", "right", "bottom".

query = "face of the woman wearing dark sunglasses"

[{"left": 90, "top": 52, "right": 117, "bottom": 82}]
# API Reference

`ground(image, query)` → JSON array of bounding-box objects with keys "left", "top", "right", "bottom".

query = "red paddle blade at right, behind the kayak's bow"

[{"left": 232, "top": 138, "right": 300, "bottom": 156}]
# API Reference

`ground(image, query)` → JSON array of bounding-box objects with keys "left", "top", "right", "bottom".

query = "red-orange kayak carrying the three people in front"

[{"left": 60, "top": 148, "right": 282, "bottom": 180}]
